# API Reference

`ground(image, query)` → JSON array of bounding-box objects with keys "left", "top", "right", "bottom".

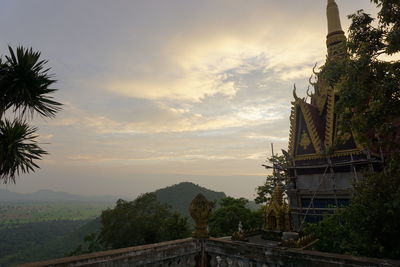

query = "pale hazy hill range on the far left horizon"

[{"left": 0, "top": 189, "right": 119, "bottom": 202}]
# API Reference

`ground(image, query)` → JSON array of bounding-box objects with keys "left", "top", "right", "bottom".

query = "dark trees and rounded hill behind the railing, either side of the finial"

[{"left": 71, "top": 183, "right": 262, "bottom": 255}]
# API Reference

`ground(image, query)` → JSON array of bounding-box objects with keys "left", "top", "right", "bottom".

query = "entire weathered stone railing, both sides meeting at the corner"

[{"left": 22, "top": 238, "right": 400, "bottom": 267}]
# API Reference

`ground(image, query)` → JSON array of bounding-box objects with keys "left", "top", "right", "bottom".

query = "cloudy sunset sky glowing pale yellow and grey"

[{"left": 0, "top": 0, "right": 376, "bottom": 199}]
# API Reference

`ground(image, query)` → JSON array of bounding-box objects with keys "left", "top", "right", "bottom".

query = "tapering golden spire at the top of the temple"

[{"left": 326, "top": 0, "right": 346, "bottom": 58}]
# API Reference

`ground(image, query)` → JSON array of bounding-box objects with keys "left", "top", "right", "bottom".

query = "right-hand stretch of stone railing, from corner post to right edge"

[{"left": 204, "top": 238, "right": 400, "bottom": 267}]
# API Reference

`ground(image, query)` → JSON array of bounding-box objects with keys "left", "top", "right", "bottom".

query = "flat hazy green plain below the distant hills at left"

[{"left": 0, "top": 202, "right": 112, "bottom": 266}]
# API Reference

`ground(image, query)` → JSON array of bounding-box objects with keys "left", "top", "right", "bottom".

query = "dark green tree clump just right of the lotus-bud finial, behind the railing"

[{"left": 209, "top": 197, "right": 262, "bottom": 237}]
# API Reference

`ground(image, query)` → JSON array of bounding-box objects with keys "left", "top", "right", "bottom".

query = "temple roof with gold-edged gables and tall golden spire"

[{"left": 289, "top": 0, "right": 362, "bottom": 160}]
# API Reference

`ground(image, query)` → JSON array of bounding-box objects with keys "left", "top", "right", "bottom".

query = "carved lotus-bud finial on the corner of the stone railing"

[{"left": 189, "top": 194, "right": 213, "bottom": 238}]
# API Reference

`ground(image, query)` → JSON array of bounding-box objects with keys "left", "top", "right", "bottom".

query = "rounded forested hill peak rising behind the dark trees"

[{"left": 154, "top": 182, "right": 226, "bottom": 217}]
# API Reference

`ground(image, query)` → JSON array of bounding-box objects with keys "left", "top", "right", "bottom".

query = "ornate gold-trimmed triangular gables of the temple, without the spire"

[{"left": 289, "top": 82, "right": 362, "bottom": 160}]
